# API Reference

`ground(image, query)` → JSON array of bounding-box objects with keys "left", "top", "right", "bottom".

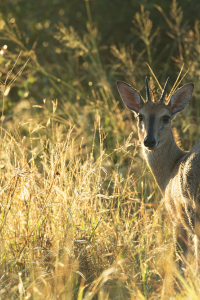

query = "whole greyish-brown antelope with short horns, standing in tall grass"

[{"left": 117, "top": 78, "right": 200, "bottom": 269}]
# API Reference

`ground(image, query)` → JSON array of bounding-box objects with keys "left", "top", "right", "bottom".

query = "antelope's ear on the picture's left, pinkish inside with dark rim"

[{"left": 117, "top": 81, "right": 144, "bottom": 114}]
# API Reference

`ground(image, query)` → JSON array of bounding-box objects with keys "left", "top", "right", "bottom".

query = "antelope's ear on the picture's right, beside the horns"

[{"left": 168, "top": 83, "right": 194, "bottom": 118}]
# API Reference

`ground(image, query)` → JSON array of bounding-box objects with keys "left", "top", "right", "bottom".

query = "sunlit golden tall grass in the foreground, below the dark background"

[{"left": 0, "top": 108, "right": 199, "bottom": 300}]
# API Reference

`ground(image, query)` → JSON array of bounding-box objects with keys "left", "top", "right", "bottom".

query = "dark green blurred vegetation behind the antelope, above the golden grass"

[{"left": 0, "top": 0, "right": 200, "bottom": 155}]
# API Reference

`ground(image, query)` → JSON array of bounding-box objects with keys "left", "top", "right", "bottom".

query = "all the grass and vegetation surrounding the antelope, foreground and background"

[{"left": 0, "top": 0, "right": 200, "bottom": 300}]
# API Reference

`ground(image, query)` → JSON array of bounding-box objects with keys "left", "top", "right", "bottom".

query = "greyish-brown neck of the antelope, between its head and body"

[{"left": 143, "top": 131, "right": 187, "bottom": 195}]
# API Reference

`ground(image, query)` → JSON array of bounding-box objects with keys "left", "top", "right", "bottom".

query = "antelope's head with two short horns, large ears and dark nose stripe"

[{"left": 117, "top": 77, "right": 194, "bottom": 150}]
